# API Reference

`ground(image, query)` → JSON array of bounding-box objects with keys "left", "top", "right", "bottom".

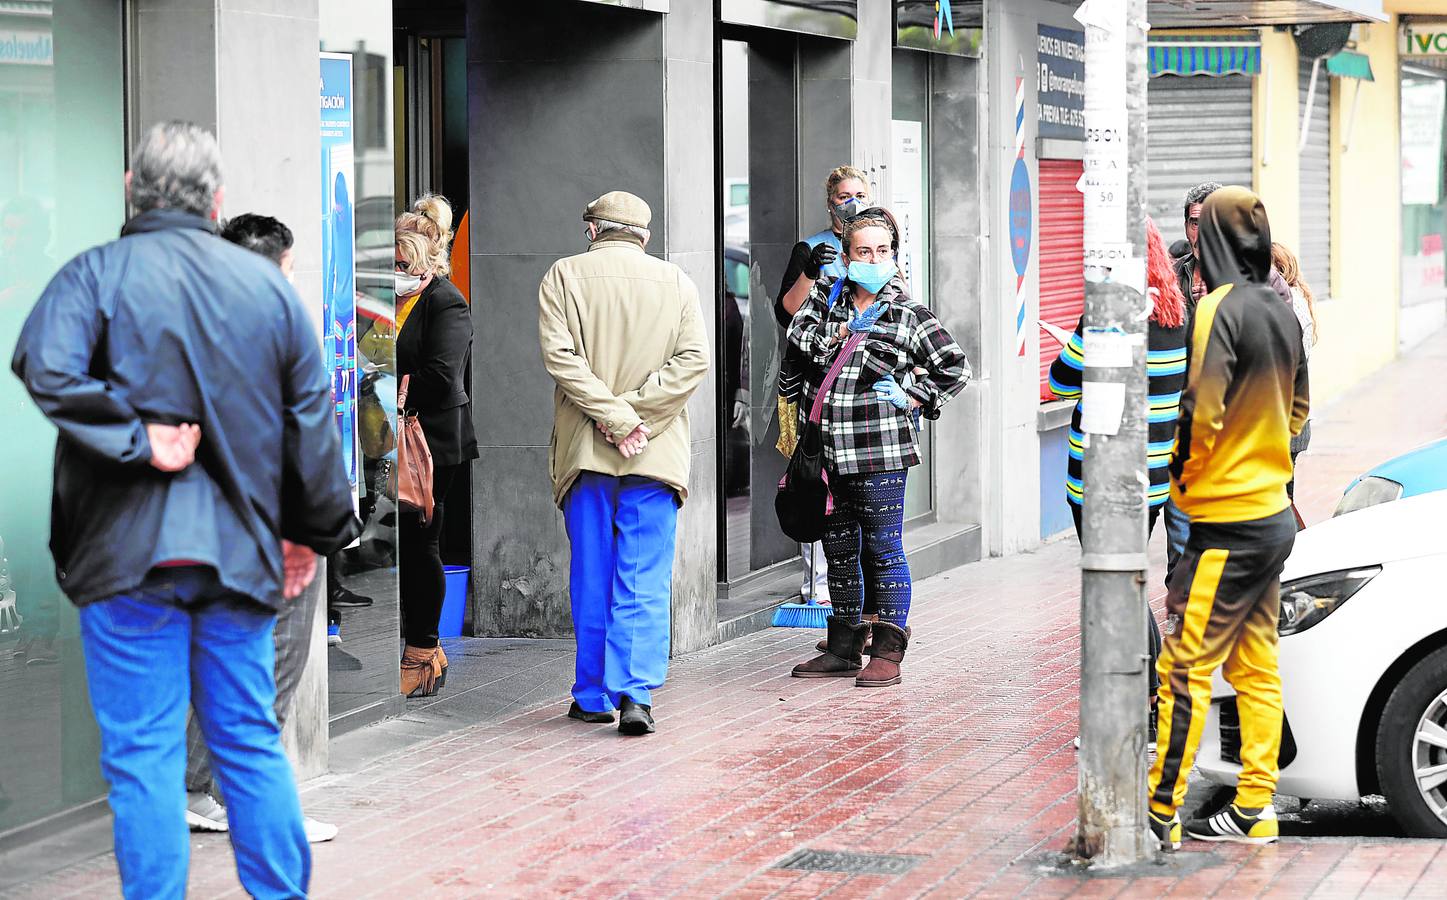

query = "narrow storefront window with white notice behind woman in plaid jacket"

[{"left": 886, "top": 51, "right": 935, "bottom": 519}]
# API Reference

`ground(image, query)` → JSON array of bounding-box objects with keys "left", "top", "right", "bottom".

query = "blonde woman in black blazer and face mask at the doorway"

[{"left": 395, "top": 194, "right": 478, "bottom": 697}]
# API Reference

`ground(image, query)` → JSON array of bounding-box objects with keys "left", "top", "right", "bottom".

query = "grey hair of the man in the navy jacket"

[{"left": 130, "top": 122, "right": 221, "bottom": 217}]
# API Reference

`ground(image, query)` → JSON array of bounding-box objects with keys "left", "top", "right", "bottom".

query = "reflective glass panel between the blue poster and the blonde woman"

[{"left": 320, "top": 0, "right": 401, "bottom": 723}]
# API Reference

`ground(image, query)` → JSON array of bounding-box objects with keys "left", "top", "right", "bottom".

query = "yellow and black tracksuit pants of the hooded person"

[{"left": 1150, "top": 508, "right": 1297, "bottom": 816}]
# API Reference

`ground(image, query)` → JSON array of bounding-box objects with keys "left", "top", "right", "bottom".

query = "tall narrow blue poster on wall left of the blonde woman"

[{"left": 321, "top": 54, "right": 357, "bottom": 502}]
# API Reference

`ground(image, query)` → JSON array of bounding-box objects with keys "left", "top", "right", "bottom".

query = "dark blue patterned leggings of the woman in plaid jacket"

[{"left": 823, "top": 470, "right": 913, "bottom": 628}]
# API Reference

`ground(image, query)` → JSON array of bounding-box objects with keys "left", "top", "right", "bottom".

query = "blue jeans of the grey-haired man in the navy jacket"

[{"left": 80, "top": 569, "right": 311, "bottom": 900}]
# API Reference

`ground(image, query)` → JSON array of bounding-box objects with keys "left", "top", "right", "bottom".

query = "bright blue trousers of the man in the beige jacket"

[{"left": 563, "top": 472, "right": 679, "bottom": 712}]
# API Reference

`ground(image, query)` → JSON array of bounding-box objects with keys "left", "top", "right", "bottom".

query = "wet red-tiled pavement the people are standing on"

[{"left": 17, "top": 341, "right": 1447, "bottom": 897}]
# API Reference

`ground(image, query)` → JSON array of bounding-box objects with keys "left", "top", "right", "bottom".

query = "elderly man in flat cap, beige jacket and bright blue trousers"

[{"left": 538, "top": 191, "right": 709, "bottom": 735}]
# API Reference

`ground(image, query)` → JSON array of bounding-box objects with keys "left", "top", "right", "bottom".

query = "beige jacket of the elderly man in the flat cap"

[{"left": 538, "top": 239, "right": 709, "bottom": 506}]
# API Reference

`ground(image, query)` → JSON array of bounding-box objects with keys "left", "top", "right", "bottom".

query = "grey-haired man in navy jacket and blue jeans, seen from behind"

[{"left": 12, "top": 123, "right": 359, "bottom": 897}]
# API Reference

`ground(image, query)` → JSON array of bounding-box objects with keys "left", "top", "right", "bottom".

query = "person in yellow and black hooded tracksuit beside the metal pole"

[{"left": 1149, "top": 187, "right": 1310, "bottom": 849}]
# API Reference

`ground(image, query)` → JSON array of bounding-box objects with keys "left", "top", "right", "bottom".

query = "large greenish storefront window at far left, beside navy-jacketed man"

[{"left": 0, "top": 0, "right": 126, "bottom": 835}]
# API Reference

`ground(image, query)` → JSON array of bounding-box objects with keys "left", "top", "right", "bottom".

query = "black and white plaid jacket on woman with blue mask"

[{"left": 781, "top": 276, "right": 969, "bottom": 475}]
